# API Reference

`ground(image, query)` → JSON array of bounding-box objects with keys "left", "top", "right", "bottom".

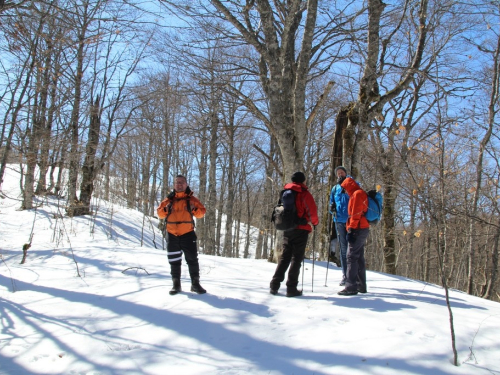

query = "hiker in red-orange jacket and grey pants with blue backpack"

[{"left": 338, "top": 177, "right": 370, "bottom": 296}]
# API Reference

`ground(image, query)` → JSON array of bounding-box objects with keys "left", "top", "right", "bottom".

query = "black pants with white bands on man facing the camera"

[{"left": 167, "top": 231, "right": 200, "bottom": 280}]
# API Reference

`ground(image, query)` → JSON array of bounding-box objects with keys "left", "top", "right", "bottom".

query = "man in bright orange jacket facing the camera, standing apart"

[{"left": 156, "top": 175, "right": 207, "bottom": 295}]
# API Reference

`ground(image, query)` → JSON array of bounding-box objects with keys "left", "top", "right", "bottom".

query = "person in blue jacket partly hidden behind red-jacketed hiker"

[{"left": 330, "top": 165, "right": 358, "bottom": 286}]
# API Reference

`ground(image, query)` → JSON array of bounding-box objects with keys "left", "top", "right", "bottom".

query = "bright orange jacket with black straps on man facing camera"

[{"left": 156, "top": 192, "right": 207, "bottom": 236}]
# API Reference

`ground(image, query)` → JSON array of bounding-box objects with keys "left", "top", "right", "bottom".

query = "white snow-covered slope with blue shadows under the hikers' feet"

[{"left": 0, "top": 168, "right": 500, "bottom": 375}]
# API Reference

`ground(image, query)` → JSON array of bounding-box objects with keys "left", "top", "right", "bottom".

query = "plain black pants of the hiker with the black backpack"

[{"left": 270, "top": 229, "right": 309, "bottom": 291}]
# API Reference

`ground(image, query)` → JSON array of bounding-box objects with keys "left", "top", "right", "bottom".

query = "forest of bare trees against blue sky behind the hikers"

[{"left": 0, "top": 0, "right": 500, "bottom": 301}]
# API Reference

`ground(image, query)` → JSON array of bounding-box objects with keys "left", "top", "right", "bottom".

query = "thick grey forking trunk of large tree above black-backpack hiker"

[{"left": 211, "top": 0, "right": 322, "bottom": 180}]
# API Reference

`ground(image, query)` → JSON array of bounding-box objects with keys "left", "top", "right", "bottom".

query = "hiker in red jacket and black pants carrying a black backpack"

[{"left": 269, "top": 172, "right": 319, "bottom": 297}]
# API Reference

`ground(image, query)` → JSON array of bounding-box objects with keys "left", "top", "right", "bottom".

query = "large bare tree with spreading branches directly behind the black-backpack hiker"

[{"left": 162, "top": 0, "right": 357, "bottom": 176}]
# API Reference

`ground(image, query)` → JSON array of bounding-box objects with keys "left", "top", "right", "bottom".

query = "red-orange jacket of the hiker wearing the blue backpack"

[{"left": 340, "top": 177, "right": 370, "bottom": 231}]
